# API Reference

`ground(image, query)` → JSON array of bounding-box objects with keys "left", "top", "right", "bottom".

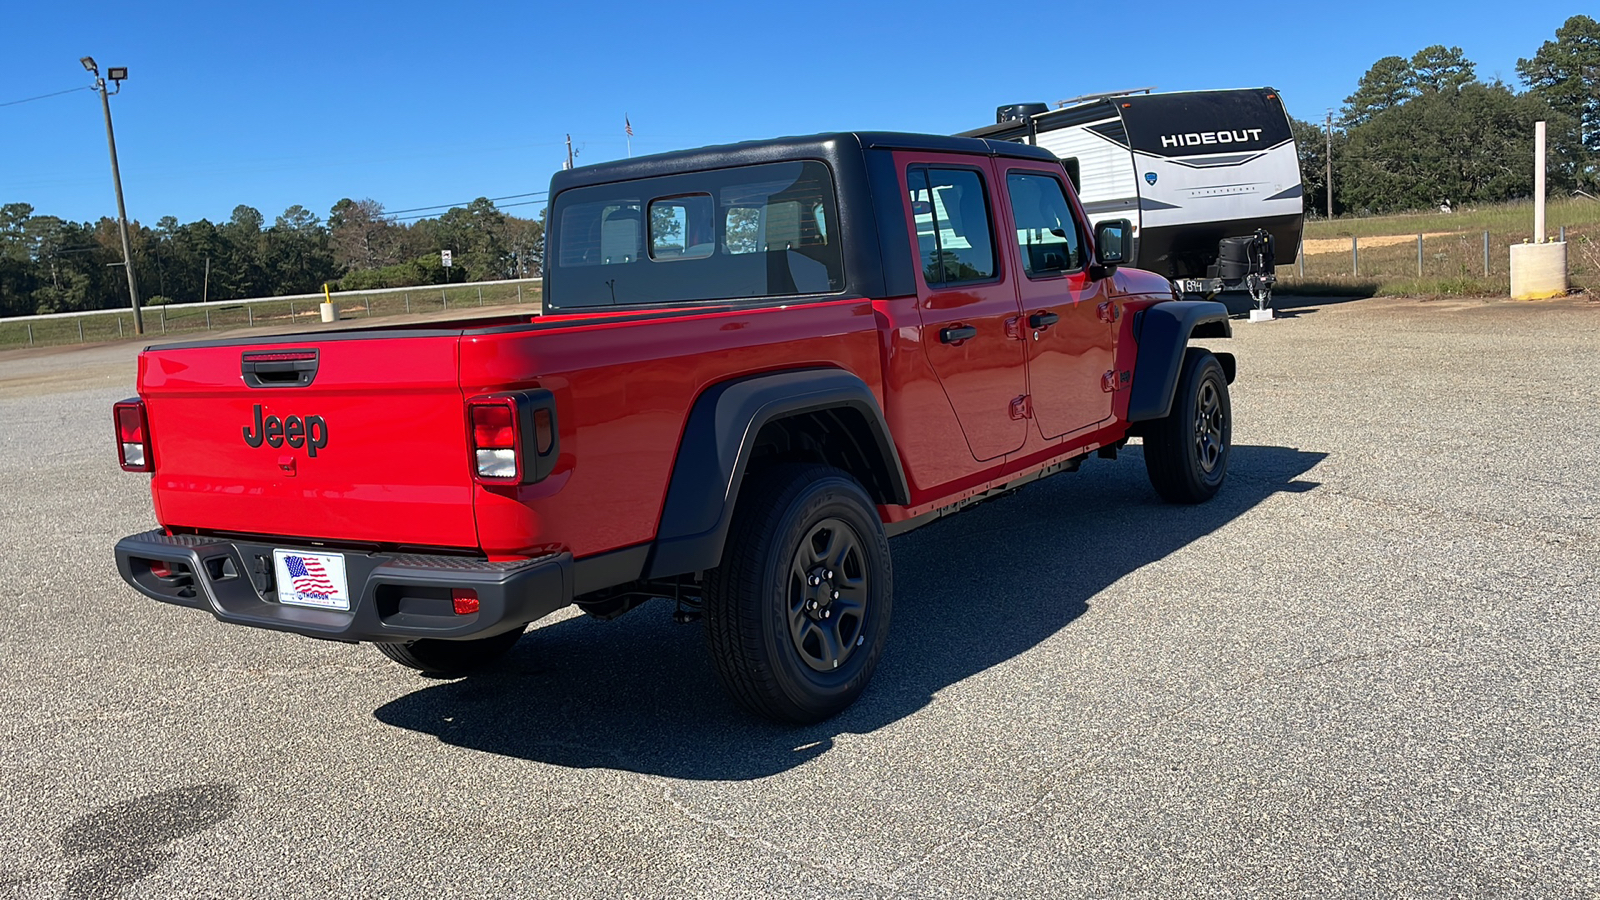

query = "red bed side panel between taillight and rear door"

[{"left": 461, "top": 299, "right": 883, "bottom": 557}]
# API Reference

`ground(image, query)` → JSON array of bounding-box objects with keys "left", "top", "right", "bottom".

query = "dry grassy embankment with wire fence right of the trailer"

[{"left": 1278, "top": 197, "right": 1600, "bottom": 296}]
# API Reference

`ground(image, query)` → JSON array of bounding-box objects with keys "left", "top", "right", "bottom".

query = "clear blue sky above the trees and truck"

[{"left": 0, "top": 0, "right": 1579, "bottom": 224}]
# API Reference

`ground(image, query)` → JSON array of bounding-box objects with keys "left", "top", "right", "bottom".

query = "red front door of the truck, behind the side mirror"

[{"left": 1003, "top": 163, "right": 1120, "bottom": 437}]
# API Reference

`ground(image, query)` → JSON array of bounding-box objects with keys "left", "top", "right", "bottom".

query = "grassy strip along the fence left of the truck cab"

[{"left": 0, "top": 283, "right": 539, "bottom": 349}]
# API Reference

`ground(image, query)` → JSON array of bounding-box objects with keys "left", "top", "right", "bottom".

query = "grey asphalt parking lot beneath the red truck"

[{"left": 0, "top": 299, "right": 1600, "bottom": 898}]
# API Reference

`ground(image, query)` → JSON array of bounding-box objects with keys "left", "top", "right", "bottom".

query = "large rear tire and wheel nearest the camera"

[{"left": 706, "top": 464, "right": 894, "bottom": 724}]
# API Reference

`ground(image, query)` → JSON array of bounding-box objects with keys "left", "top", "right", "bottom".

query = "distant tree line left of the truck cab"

[{"left": 0, "top": 197, "right": 544, "bottom": 315}]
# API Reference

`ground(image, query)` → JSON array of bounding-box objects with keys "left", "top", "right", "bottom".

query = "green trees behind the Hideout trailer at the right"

[{"left": 1291, "top": 16, "right": 1600, "bottom": 216}]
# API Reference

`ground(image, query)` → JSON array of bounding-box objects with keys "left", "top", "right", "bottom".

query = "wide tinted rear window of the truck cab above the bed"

[{"left": 546, "top": 160, "right": 845, "bottom": 309}]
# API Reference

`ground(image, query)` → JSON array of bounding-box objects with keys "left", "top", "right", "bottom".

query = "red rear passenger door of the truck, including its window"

[{"left": 896, "top": 154, "right": 1027, "bottom": 463}]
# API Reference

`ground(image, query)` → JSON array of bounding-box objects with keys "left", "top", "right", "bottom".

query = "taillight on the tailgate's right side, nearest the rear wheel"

[{"left": 467, "top": 389, "right": 562, "bottom": 484}]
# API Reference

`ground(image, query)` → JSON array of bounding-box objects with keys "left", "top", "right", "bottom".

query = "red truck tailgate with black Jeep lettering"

[{"left": 139, "top": 331, "right": 478, "bottom": 548}]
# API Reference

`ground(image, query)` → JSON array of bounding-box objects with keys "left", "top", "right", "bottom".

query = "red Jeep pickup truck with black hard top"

[{"left": 114, "top": 133, "right": 1234, "bottom": 722}]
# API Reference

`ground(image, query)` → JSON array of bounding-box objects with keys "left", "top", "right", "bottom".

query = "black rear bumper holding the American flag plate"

[{"left": 117, "top": 530, "right": 573, "bottom": 642}]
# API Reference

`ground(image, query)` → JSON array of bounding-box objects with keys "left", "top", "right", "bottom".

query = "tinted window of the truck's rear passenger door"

[{"left": 906, "top": 167, "right": 995, "bottom": 285}]
